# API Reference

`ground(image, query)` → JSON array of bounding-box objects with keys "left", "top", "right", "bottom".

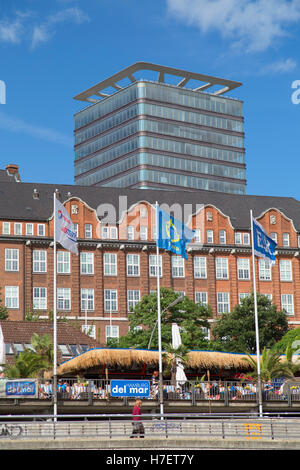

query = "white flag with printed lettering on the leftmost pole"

[{"left": 54, "top": 199, "right": 78, "bottom": 255}]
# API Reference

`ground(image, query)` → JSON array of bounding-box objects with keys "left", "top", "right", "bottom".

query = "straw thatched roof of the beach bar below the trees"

[{"left": 44, "top": 348, "right": 254, "bottom": 376}]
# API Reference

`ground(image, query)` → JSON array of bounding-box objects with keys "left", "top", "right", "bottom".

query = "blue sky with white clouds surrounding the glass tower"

[{"left": 0, "top": 0, "right": 300, "bottom": 199}]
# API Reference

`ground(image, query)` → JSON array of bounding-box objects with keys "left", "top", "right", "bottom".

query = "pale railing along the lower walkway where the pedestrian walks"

[{"left": 0, "top": 414, "right": 300, "bottom": 442}]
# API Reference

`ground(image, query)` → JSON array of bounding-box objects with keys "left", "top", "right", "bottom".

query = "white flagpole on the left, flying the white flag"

[{"left": 53, "top": 193, "right": 57, "bottom": 421}]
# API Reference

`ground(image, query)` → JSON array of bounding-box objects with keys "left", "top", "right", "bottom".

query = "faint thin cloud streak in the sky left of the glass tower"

[{"left": 0, "top": 112, "right": 73, "bottom": 148}]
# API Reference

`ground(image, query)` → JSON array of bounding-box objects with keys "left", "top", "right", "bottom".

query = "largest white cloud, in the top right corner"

[{"left": 167, "top": 0, "right": 300, "bottom": 52}]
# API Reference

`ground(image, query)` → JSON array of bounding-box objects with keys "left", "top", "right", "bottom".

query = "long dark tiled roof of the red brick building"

[{"left": 0, "top": 182, "right": 300, "bottom": 232}]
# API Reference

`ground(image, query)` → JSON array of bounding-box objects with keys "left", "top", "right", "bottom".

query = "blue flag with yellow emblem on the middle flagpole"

[{"left": 156, "top": 206, "right": 195, "bottom": 259}]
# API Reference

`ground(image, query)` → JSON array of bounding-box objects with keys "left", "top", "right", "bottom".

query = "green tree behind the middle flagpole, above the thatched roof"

[{"left": 115, "top": 287, "right": 211, "bottom": 349}]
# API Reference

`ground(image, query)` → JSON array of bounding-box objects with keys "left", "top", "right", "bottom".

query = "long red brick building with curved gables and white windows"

[{"left": 0, "top": 165, "right": 300, "bottom": 345}]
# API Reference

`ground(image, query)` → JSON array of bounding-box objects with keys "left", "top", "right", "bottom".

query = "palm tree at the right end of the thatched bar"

[{"left": 245, "top": 348, "right": 299, "bottom": 382}]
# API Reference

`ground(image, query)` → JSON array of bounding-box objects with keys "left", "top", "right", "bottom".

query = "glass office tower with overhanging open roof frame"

[{"left": 75, "top": 66, "right": 246, "bottom": 194}]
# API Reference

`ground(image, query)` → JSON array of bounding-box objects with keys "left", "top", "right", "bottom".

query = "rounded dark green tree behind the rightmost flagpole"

[{"left": 212, "top": 293, "right": 288, "bottom": 354}]
